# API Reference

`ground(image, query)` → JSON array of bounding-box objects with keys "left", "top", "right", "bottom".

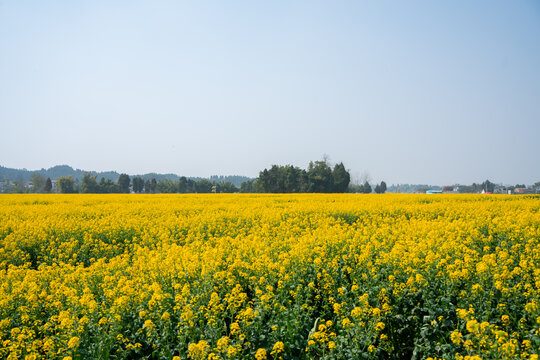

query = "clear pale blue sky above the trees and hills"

[{"left": 0, "top": 0, "right": 540, "bottom": 184}]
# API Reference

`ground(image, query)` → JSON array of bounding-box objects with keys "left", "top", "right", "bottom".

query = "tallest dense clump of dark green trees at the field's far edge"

[{"left": 240, "top": 160, "right": 351, "bottom": 193}]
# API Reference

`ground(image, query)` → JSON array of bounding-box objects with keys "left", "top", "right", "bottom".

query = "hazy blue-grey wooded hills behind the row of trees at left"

[{"left": 0, "top": 165, "right": 251, "bottom": 187}]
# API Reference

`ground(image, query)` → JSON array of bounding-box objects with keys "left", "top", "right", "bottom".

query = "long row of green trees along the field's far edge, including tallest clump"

[{"left": 3, "top": 159, "right": 392, "bottom": 194}]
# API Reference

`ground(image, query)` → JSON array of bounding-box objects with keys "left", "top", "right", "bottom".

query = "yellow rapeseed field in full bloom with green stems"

[{"left": 0, "top": 194, "right": 540, "bottom": 359}]
